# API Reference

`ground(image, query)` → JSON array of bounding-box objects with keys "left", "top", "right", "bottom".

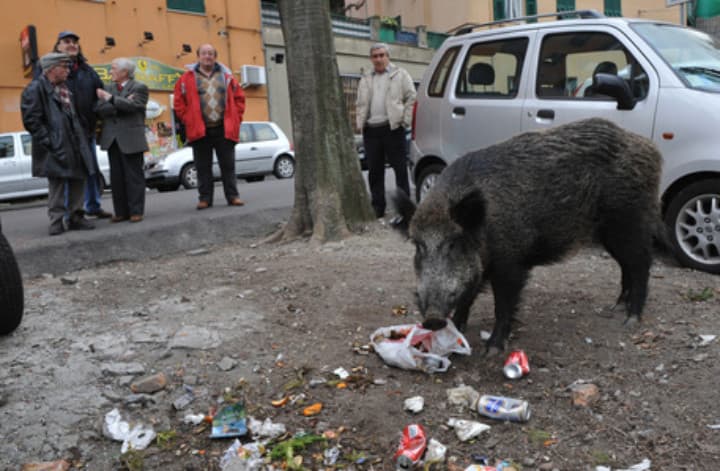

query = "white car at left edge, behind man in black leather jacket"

[{"left": 0, "top": 132, "right": 110, "bottom": 200}]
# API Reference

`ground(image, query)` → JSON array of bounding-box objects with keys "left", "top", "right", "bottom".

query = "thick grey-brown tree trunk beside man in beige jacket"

[{"left": 276, "top": 0, "right": 374, "bottom": 242}]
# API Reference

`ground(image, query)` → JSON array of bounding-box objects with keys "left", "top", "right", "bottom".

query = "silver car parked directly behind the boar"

[{"left": 410, "top": 12, "right": 720, "bottom": 273}]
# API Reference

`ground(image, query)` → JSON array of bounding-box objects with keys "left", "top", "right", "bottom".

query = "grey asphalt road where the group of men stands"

[{"left": 0, "top": 170, "right": 395, "bottom": 277}]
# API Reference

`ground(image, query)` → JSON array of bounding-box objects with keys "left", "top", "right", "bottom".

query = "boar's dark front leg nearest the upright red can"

[{"left": 487, "top": 266, "right": 528, "bottom": 355}]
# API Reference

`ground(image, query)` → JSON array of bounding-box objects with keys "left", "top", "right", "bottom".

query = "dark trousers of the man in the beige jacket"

[{"left": 363, "top": 124, "right": 410, "bottom": 217}]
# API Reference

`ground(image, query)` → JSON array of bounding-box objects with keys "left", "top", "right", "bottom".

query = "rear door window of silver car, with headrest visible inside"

[{"left": 455, "top": 38, "right": 528, "bottom": 98}]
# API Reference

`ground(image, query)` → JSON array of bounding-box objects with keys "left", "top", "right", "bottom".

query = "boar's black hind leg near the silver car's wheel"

[{"left": 601, "top": 221, "right": 652, "bottom": 323}]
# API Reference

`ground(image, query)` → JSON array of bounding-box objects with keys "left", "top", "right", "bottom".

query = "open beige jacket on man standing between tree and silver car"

[{"left": 356, "top": 64, "right": 415, "bottom": 130}]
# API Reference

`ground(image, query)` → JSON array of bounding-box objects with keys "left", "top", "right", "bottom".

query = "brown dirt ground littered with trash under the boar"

[{"left": 0, "top": 224, "right": 720, "bottom": 470}]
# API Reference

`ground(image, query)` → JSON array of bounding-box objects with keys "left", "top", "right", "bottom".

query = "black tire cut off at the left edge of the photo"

[{"left": 0, "top": 232, "right": 24, "bottom": 335}]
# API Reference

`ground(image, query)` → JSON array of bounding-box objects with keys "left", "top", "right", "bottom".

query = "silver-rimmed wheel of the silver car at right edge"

[{"left": 665, "top": 179, "right": 720, "bottom": 273}]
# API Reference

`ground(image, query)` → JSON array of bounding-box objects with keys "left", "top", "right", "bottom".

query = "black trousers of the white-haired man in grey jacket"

[{"left": 108, "top": 141, "right": 145, "bottom": 218}]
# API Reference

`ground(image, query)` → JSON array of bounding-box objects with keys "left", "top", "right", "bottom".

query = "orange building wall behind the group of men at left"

[{"left": 0, "top": 0, "right": 268, "bottom": 132}]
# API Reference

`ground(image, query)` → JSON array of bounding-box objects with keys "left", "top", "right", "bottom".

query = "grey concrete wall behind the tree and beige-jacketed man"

[{"left": 262, "top": 26, "right": 435, "bottom": 140}]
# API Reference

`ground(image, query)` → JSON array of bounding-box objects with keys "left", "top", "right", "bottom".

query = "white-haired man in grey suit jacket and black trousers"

[{"left": 97, "top": 58, "right": 148, "bottom": 222}]
